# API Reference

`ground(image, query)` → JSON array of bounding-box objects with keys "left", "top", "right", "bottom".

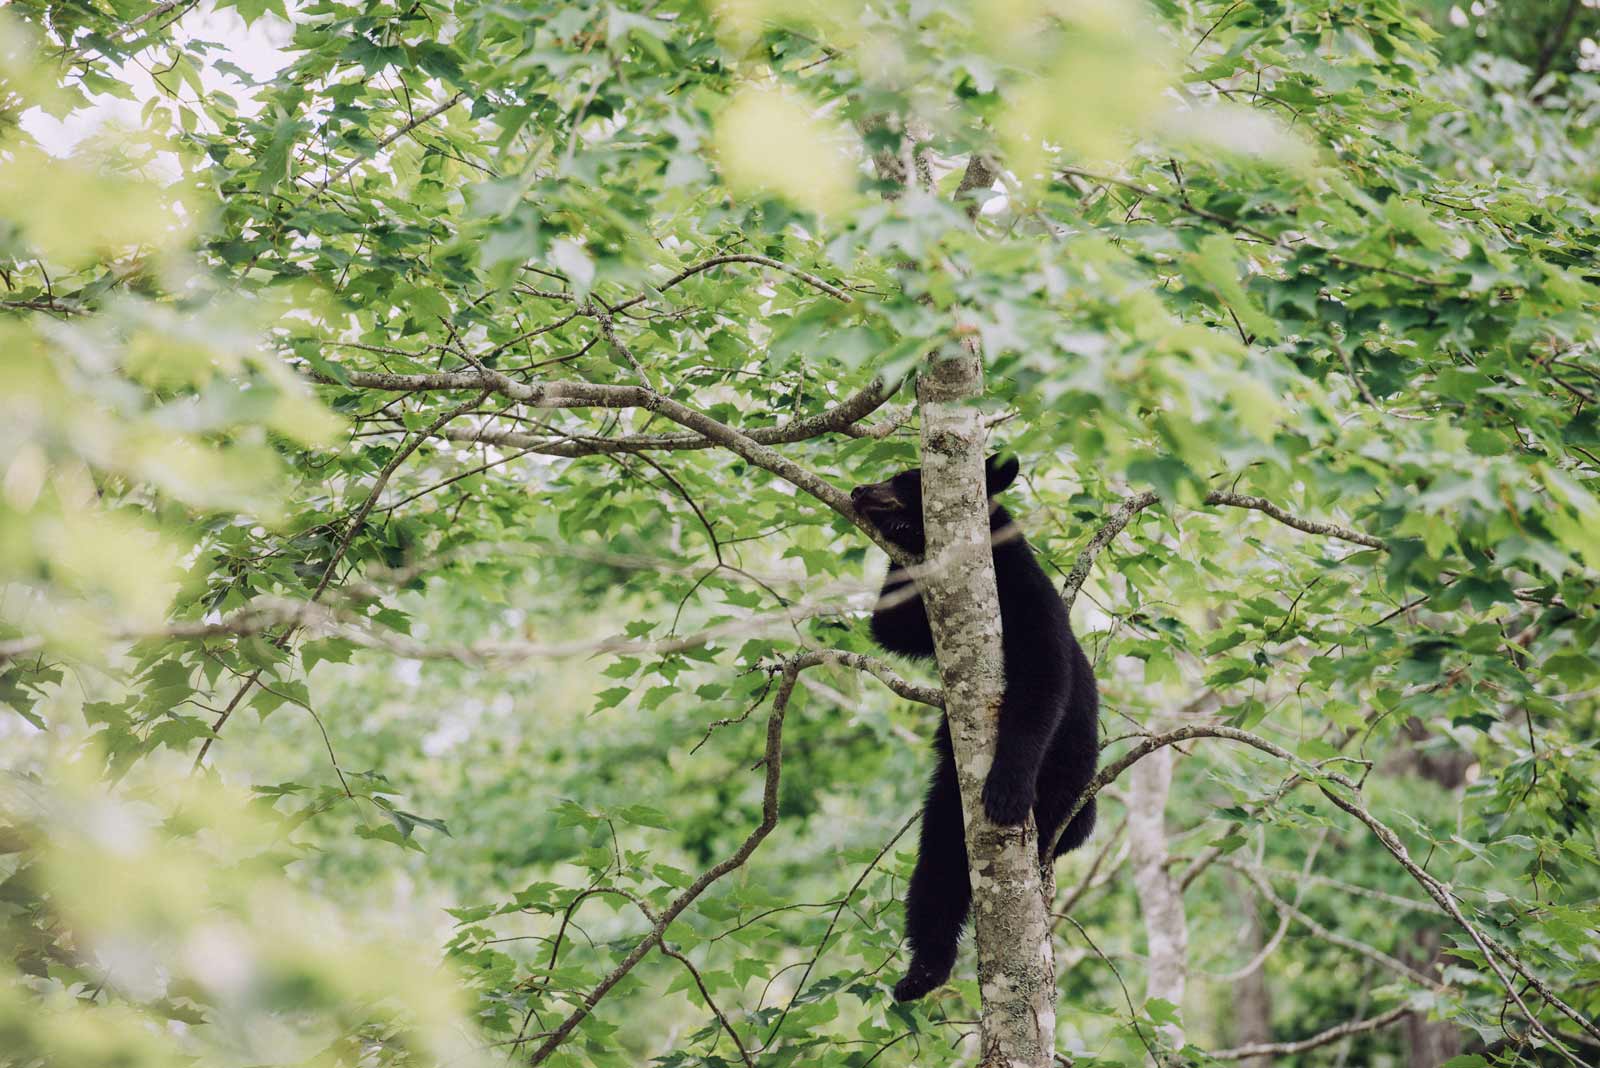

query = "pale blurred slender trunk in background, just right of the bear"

[{"left": 1128, "top": 747, "right": 1189, "bottom": 1046}]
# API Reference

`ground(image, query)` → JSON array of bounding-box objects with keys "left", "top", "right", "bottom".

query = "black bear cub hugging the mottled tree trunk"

[{"left": 850, "top": 456, "right": 1099, "bottom": 1001}]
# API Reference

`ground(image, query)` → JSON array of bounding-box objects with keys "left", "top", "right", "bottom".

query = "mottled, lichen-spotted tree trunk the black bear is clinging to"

[{"left": 917, "top": 345, "right": 1056, "bottom": 1068}]
